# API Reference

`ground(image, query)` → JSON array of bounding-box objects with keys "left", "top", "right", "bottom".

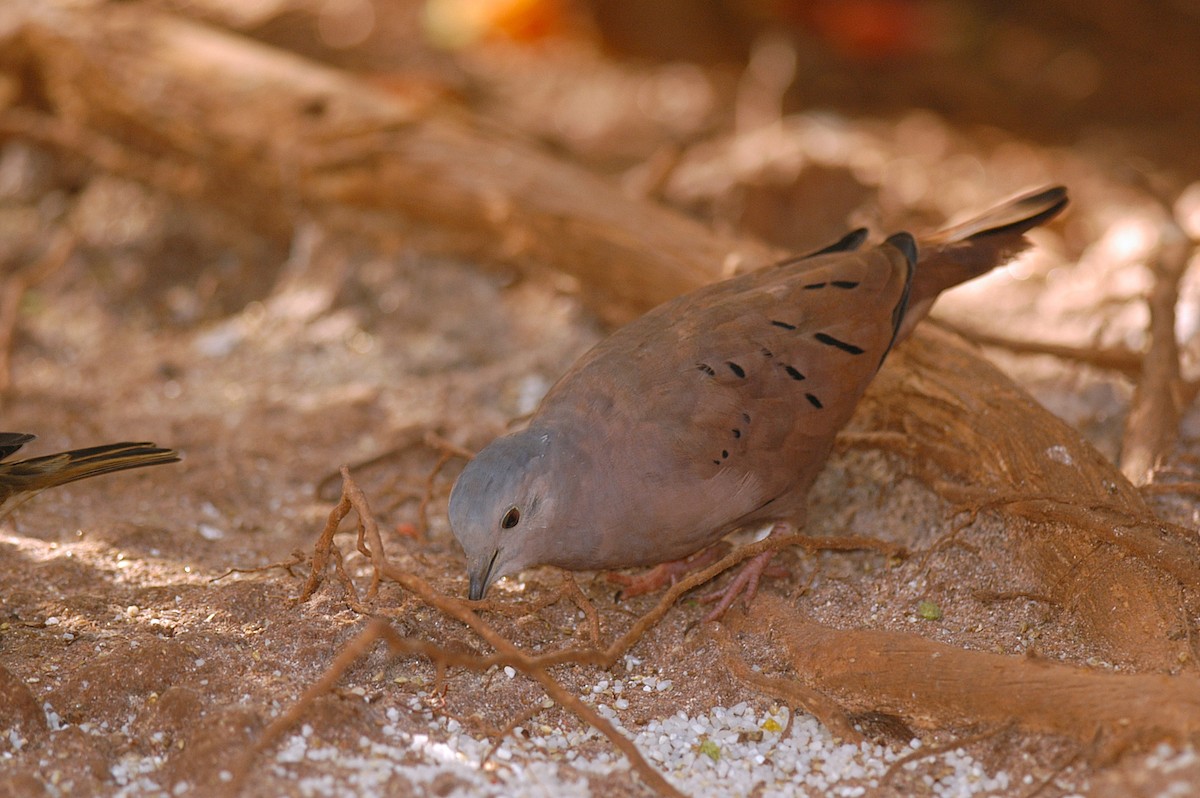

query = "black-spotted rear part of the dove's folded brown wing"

[{"left": 657, "top": 245, "right": 908, "bottom": 480}]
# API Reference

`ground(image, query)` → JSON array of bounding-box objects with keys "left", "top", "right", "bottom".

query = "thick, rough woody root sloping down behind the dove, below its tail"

[{"left": 844, "top": 330, "right": 1200, "bottom": 671}]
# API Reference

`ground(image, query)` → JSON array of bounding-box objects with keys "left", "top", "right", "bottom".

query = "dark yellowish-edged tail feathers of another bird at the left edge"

[{"left": 0, "top": 432, "right": 179, "bottom": 515}]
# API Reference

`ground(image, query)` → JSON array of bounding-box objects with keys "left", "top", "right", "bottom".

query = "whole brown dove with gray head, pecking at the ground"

[{"left": 450, "top": 187, "right": 1067, "bottom": 617}]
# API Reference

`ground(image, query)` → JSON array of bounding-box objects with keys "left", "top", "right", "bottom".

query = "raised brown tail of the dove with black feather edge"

[{"left": 896, "top": 186, "right": 1067, "bottom": 338}]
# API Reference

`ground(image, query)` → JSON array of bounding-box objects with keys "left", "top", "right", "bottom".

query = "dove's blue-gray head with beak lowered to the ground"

[{"left": 450, "top": 428, "right": 557, "bottom": 600}]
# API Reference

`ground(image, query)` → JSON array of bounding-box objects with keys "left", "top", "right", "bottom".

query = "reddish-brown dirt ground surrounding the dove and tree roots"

[{"left": 0, "top": 2, "right": 1200, "bottom": 796}]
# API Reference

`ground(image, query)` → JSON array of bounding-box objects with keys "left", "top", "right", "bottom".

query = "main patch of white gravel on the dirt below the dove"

[{"left": 241, "top": 684, "right": 1051, "bottom": 798}]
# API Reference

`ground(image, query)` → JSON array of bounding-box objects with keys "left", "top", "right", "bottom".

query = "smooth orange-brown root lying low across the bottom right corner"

[{"left": 752, "top": 595, "right": 1200, "bottom": 760}]
